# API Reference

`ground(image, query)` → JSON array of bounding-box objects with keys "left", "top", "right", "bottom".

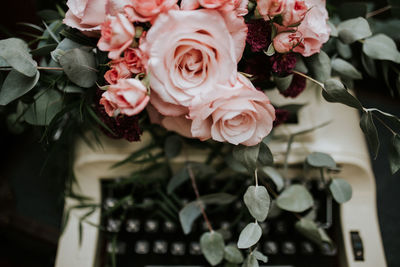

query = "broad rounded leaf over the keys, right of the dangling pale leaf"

[{"left": 276, "top": 184, "right": 314, "bottom": 212}]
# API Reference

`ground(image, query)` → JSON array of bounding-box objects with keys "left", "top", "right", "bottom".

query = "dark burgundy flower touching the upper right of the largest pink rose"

[{"left": 246, "top": 19, "right": 271, "bottom": 52}]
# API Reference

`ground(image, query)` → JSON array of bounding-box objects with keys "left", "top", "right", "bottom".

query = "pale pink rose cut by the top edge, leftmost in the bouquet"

[{"left": 63, "top": 0, "right": 129, "bottom": 33}]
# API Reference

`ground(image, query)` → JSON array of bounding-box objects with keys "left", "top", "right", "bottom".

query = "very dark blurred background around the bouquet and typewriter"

[{"left": 0, "top": 0, "right": 400, "bottom": 267}]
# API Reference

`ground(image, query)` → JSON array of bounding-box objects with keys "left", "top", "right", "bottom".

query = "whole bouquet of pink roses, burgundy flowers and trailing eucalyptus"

[{"left": 0, "top": 0, "right": 400, "bottom": 266}]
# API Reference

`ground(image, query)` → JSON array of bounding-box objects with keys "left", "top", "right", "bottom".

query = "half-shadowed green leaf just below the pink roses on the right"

[{"left": 304, "top": 51, "right": 332, "bottom": 82}]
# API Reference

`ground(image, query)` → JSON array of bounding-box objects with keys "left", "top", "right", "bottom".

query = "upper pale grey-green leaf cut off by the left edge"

[{"left": 0, "top": 38, "right": 37, "bottom": 77}]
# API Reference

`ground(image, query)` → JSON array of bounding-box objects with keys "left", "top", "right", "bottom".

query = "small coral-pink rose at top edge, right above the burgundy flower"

[{"left": 282, "top": 0, "right": 308, "bottom": 27}]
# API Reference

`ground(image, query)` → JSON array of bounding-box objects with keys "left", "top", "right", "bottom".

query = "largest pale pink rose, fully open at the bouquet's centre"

[{"left": 140, "top": 9, "right": 247, "bottom": 116}]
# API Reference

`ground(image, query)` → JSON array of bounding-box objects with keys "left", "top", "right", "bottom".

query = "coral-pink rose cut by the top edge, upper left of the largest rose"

[{"left": 125, "top": 0, "right": 178, "bottom": 22}]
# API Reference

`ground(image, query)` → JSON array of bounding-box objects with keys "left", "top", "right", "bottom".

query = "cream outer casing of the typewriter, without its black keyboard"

[{"left": 55, "top": 86, "right": 386, "bottom": 267}]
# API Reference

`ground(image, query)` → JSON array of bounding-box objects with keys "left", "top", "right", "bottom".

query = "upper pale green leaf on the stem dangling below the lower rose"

[{"left": 244, "top": 185, "right": 271, "bottom": 222}]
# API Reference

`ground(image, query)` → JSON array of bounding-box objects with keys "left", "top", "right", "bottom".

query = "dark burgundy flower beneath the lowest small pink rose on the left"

[{"left": 95, "top": 89, "right": 142, "bottom": 142}]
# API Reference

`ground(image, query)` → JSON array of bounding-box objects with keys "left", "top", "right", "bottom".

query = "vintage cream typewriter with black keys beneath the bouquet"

[{"left": 55, "top": 87, "right": 386, "bottom": 267}]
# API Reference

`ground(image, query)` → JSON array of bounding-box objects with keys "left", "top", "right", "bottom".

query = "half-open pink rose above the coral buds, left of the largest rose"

[{"left": 97, "top": 14, "right": 135, "bottom": 59}]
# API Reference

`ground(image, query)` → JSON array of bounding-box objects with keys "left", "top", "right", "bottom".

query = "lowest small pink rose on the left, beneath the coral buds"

[{"left": 100, "top": 79, "right": 150, "bottom": 117}]
